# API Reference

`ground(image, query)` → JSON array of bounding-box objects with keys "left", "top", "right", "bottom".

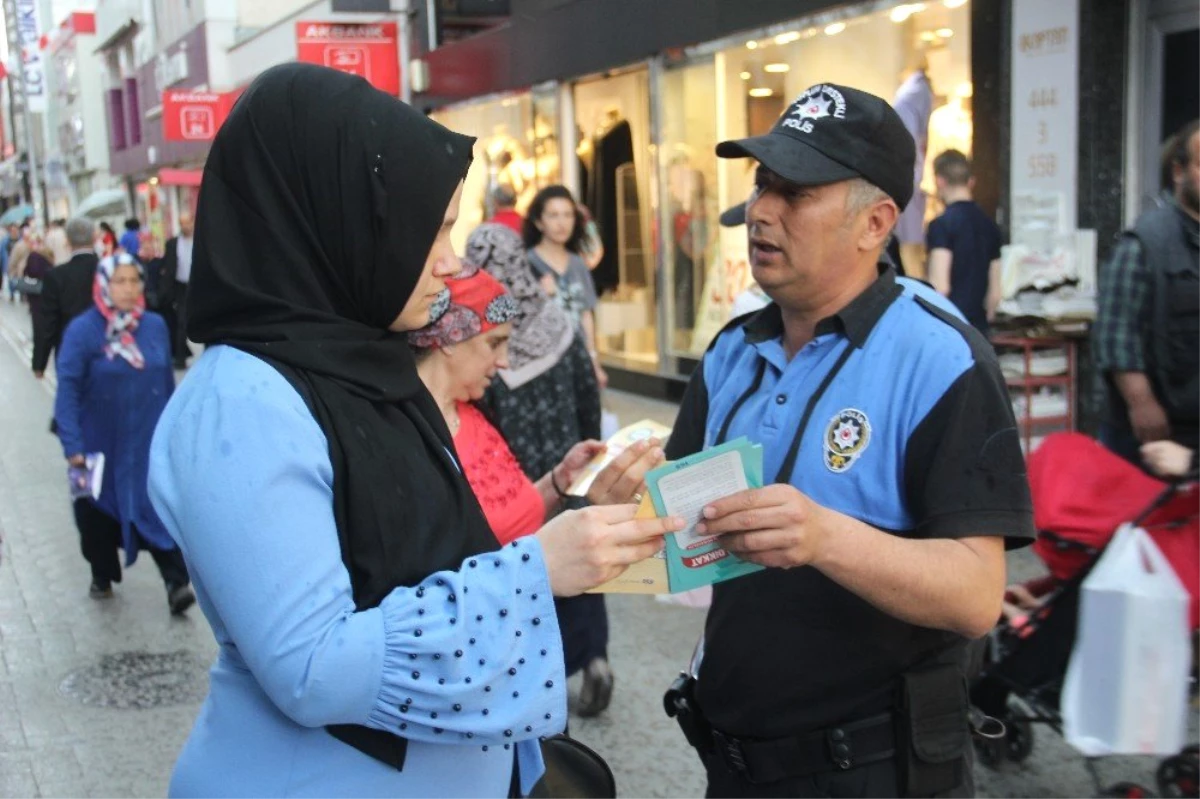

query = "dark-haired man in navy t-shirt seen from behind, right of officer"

[{"left": 925, "top": 150, "right": 1001, "bottom": 336}]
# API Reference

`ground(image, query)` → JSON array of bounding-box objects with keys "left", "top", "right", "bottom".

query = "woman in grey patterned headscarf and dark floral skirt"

[{"left": 467, "top": 224, "right": 613, "bottom": 716}]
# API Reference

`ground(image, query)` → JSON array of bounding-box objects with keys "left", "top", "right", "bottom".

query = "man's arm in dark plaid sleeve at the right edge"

[{"left": 1092, "top": 236, "right": 1171, "bottom": 444}]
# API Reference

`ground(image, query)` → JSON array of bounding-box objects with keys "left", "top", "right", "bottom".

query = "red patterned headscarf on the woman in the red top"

[{"left": 408, "top": 263, "right": 517, "bottom": 349}]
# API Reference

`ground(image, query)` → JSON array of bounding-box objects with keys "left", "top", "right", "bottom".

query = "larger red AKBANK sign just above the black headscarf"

[{"left": 296, "top": 22, "right": 400, "bottom": 97}]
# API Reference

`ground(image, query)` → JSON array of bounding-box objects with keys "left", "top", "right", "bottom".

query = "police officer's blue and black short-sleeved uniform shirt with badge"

[{"left": 667, "top": 269, "right": 1033, "bottom": 738}]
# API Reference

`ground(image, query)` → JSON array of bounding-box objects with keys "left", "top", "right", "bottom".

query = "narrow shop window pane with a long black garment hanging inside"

[{"left": 574, "top": 70, "right": 659, "bottom": 371}]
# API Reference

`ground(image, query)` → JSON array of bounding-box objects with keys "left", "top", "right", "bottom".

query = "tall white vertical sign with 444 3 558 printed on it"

[{"left": 1009, "top": 0, "right": 1079, "bottom": 232}]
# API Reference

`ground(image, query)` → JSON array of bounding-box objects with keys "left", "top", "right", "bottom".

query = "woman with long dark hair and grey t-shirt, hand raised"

[{"left": 522, "top": 186, "right": 608, "bottom": 389}]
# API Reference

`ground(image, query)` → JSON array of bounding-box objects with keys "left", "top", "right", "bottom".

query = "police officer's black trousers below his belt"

[{"left": 704, "top": 744, "right": 974, "bottom": 799}]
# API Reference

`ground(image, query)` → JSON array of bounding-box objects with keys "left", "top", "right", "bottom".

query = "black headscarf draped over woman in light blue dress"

[{"left": 187, "top": 64, "right": 498, "bottom": 768}]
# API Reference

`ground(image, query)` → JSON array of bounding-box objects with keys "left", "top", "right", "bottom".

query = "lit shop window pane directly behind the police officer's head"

[{"left": 659, "top": 1, "right": 972, "bottom": 358}]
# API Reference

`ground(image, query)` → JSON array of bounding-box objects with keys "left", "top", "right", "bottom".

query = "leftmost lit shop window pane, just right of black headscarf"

[{"left": 431, "top": 88, "right": 562, "bottom": 252}]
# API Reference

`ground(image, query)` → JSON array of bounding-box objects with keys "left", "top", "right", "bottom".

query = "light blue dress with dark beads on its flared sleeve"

[{"left": 150, "top": 347, "right": 566, "bottom": 799}]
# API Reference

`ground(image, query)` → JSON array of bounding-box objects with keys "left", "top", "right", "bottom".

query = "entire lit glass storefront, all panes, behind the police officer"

[{"left": 433, "top": 0, "right": 972, "bottom": 376}]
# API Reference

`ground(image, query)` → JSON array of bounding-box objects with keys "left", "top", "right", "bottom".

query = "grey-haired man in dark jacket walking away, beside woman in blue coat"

[{"left": 34, "top": 218, "right": 100, "bottom": 378}]
